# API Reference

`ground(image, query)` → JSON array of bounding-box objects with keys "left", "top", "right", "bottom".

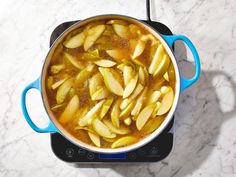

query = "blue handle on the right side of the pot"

[{"left": 162, "top": 35, "right": 201, "bottom": 92}]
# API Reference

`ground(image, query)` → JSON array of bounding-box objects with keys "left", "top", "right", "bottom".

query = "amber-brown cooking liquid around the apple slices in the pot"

[{"left": 46, "top": 20, "right": 175, "bottom": 148}]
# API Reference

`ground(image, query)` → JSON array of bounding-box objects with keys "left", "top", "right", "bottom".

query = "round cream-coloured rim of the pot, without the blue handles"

[{"left": 40, "top": 14, "right": 180, "bottom": 153}]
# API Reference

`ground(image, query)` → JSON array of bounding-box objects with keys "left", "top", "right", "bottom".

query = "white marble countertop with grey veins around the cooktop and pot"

[{"left": 0, "top": 0, "right": 236, "bottom": 177}]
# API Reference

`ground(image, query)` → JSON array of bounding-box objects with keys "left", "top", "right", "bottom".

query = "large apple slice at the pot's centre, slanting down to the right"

[{"left": 98, "top": 67, "right": 124, "bottom": 96}]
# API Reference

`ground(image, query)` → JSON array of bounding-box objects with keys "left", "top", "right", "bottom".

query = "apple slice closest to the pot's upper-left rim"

[{"left": 63, "top": 32, "right": 85, "bottom": 49}]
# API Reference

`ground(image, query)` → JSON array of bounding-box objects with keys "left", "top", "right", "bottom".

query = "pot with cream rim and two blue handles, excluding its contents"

[{"left": 21, "top": 15, "right": 200, "bottom": 153}]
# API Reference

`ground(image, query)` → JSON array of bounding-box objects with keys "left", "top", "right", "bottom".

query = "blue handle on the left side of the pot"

[{"left": 21, "top": 77, "right": 59, "bottom": 133}]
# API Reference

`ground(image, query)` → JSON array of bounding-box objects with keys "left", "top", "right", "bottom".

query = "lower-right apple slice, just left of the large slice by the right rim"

[{"left": 136, "top": 104, "right": 156, "bottom": 131}]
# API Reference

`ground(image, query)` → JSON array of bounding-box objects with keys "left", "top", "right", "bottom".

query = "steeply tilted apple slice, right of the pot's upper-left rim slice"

[{"left": 84, "top": 25, "right": 105, "bottom": 51}]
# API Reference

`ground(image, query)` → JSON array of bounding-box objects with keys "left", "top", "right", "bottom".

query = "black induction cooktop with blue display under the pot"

[{"left": 50, "top": 20, "right": 174, "bottom": 163}]
